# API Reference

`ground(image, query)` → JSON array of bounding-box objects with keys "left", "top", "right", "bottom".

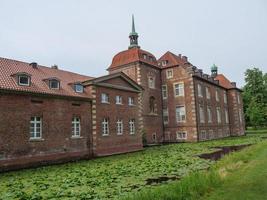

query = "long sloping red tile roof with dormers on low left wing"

[{"left": 0, "top": 58, "right": 92, "bottom": 98}]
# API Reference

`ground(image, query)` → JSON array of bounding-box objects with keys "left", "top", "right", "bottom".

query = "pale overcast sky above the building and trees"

[{"left": 0, "top": 0, "right": 267, "bottom": 86}]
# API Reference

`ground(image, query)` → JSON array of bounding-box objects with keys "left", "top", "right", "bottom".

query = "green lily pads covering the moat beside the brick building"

[{"left": 0, "top": 134, "right": 267, "bottom": 200}]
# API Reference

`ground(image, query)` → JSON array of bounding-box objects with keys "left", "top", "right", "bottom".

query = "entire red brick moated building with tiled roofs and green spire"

[{"left": 0, "top": 17, "right": 245, "bottom": 171}]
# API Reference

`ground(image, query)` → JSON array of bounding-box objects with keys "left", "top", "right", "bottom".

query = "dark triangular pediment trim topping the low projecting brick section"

[{"left": 83, "top": 72, "right": 143, "bottom": 92}]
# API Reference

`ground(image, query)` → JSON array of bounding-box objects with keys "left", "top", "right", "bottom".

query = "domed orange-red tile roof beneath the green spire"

[{"left": 108, "top": 48, "right": 158, "bottom": 70}]
